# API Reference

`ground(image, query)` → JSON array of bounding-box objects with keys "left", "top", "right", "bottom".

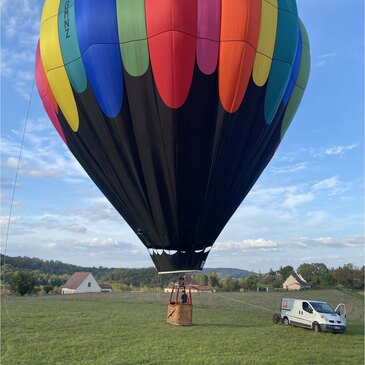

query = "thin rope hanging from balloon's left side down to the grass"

[{"left": 3, "top": 79, "right": 34, "bottom": 322}]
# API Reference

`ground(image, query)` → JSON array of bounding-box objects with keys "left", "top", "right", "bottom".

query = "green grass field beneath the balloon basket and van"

[{"left": 1, "top": 290, "right": 364, "bottom": 365}]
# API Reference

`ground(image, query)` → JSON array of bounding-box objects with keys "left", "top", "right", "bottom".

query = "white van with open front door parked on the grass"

[{"left": 280, "top": 298, "right": 346, "bottom": 333}]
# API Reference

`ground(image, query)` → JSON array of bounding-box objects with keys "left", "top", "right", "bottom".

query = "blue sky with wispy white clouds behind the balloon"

[{"left": 0, "top": 0, "right": 364, "bottom": 272}]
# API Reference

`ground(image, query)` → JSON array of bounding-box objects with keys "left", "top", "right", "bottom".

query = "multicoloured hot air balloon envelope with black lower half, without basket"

[{"left": 36, "top": 0, "right": 310, "bottom": 273}]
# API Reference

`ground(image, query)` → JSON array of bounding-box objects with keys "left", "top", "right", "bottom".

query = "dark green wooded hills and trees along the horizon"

[{"left": 1, "top": 255, "right": 364, "bottom": 295}]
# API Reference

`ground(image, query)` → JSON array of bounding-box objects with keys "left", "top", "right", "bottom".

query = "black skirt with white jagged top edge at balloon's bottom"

[{"left": 149, "top": 246, "right": 212, "bottom": 274}]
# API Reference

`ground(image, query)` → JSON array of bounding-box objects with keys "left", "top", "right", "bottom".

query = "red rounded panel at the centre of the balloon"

[{"left": 145, "top": 0, "right": 197, "bottom": 108}]
